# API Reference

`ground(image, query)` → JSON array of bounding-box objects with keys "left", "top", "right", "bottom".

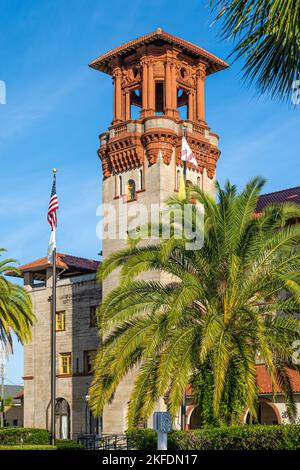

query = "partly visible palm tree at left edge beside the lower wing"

[{"left": 0, "top": 248, "right": 34, "bottom": 349}]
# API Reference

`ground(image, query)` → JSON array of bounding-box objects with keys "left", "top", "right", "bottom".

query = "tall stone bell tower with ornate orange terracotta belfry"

[{"left": 90, "top": 28, "right": 228, "bottom": 433}]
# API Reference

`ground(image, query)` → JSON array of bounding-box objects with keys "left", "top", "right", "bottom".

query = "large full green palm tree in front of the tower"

[{"left": 90, "top": 178, "right": 300, "bottom": 426}]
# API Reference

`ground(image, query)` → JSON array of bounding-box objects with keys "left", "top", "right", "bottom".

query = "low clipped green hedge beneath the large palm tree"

[{"left": 127, "top": 424, "right": 300, "bottom": 450}]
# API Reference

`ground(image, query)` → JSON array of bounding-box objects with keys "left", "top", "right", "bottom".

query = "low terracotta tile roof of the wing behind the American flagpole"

[{"left": 7, "top": 253, "right": 100, "bottom": 276}]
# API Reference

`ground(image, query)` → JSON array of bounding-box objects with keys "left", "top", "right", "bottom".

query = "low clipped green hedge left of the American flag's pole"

[{"left": 0, "top": 428, "right": 50, "bottom": 446}]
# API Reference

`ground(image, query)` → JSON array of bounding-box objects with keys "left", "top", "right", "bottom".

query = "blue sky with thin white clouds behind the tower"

[{"left": 0, "top": 0, "right": 300, "bottom": 383}]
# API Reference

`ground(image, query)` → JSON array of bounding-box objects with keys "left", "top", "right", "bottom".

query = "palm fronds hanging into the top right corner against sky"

[{"left": 211, "top": 0, "right": 300, "bottom": 98}]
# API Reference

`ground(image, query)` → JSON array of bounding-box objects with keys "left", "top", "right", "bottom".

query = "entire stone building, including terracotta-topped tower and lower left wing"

[{"left": 9, "top": 28, "right": 300, "bottom": 437}]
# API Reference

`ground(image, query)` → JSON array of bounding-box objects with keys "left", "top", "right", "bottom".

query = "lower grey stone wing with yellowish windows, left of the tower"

[{"left": 8, "top": 253, "right": 101, "bottom": 438}]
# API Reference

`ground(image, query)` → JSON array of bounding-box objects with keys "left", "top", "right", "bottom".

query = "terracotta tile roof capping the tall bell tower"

[{"left": 89, "top": 28, "right": 228, "bottom": 75}]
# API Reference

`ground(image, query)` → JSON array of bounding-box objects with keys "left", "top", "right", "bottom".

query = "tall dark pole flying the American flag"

[{"left": 51, "top": 168, "right": 56, "bottom": 445}]
